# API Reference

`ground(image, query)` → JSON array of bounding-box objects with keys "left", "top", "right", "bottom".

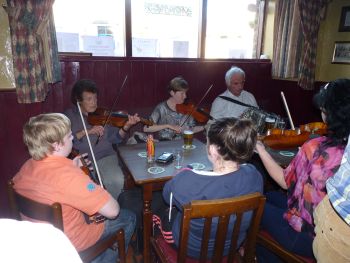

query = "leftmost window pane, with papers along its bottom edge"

[{"left": 53, "top": 0, "right": 125, "bottom": 56}]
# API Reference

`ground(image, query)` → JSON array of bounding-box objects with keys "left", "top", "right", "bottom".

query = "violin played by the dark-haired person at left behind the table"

[{"left": 88, "top": 108, "right": 153, "bottom": 128}]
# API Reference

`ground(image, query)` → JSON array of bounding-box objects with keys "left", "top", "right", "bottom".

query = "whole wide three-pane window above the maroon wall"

[{"left": 53, "top": 0, "right": 263, "bottom": 59}]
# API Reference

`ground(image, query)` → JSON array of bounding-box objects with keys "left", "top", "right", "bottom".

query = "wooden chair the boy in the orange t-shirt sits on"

[{"left": 7, "top": 180, "right": 126, "bottom": 263}]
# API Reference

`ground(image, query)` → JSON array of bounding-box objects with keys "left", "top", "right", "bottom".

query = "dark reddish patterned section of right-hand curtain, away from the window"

[{"left": 298, "top": 0, "right": 331, "bottom": 90}]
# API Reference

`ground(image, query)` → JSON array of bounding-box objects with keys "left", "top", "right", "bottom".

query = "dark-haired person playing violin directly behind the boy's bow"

[{"left": 65, "top": 79, "right": 140, "bottom": 198}]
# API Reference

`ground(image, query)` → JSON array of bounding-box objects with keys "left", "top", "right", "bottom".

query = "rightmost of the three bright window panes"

[{"left": 205, "top": 0, "right": 258, "bottom": 58}]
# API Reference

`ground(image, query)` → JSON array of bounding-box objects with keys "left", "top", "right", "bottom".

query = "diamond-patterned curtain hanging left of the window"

[{"left": 7, "top": 0, "right": 61, "bottom": 103}]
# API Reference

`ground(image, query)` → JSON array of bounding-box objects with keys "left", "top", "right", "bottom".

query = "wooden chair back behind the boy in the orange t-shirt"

[{"left": 7, "top": 180, "right": 63, "bottom": 231}]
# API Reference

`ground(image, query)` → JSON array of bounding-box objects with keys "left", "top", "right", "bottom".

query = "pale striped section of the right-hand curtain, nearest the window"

[{"left": 272, "top": 0, "right": 304, "bottom": 79}]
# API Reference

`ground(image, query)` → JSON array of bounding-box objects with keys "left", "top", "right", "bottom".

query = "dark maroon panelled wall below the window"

[{"left": 0, "top": 57, "right": 318, "bottom": 216}]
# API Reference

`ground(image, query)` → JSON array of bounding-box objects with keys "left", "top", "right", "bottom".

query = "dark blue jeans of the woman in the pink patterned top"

[{"left": 256, "top": 191, "right": 313, "bottom": 263}]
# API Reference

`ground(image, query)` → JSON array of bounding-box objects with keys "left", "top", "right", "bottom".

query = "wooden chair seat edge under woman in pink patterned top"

[{"left": 257, "top": 230, "right": 316, "bottom": 263}]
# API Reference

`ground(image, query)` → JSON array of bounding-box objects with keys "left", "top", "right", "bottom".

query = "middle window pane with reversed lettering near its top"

[{"left": 131, "top": 0, "right": 201, "bottom": 58}]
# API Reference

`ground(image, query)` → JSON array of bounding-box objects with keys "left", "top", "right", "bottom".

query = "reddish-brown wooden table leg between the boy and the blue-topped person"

[{"left": 142, "top": 183, "right": 152, "bottom": 263}]
